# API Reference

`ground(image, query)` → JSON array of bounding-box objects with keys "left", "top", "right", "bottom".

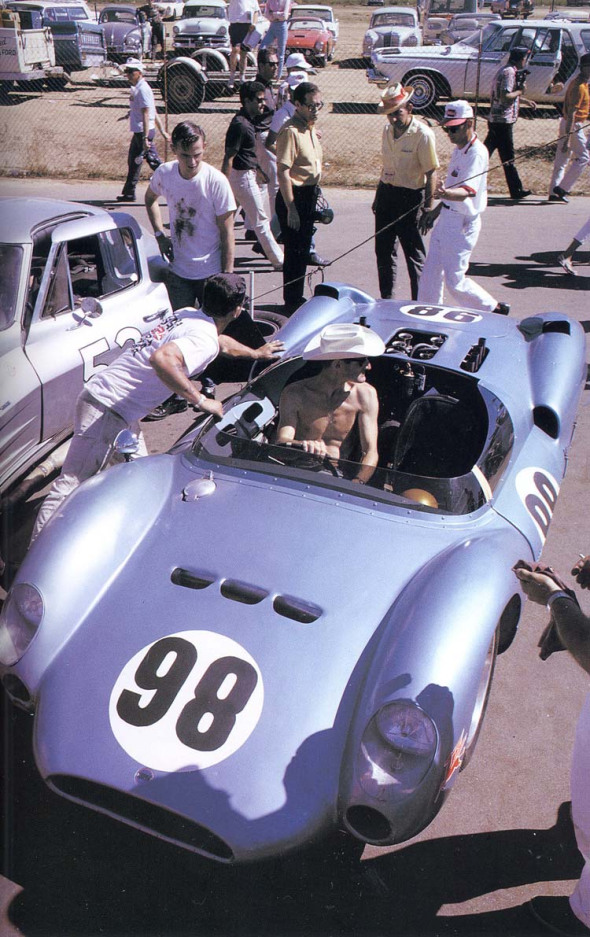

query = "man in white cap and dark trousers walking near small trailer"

[{"left": 117, "top": 59, "right": 170, "bottom": 202}]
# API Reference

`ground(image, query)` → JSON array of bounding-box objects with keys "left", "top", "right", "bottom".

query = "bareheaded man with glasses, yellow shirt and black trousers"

[{"left": 276, "top": 81, "right": 324, "bottom": 315}]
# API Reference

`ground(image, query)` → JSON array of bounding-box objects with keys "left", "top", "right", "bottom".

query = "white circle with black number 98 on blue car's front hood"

[{"left": 109, "top": 631, "right": 264, "bottom": 771}]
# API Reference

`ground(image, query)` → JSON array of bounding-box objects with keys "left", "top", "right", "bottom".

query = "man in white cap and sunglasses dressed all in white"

[{"left": 418, "top": 100, "right": 510, "bottom": 315}]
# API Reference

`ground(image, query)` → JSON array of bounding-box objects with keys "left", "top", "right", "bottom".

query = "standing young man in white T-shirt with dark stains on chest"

[{"left": 145, "top": 120, "right": 236, "bottom": 309}]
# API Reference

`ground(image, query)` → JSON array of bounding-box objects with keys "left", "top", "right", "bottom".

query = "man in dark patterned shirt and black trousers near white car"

[{"left": 484, "top": 46, "right": 537, "bottom": 201}]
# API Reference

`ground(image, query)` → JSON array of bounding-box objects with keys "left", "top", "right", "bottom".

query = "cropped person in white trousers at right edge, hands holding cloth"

[{"left": 514, "top": 556, "right": 590, "bottom": 937}]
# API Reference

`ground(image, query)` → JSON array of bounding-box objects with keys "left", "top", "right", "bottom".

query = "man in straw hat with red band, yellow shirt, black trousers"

[{"left": 373, "top": 82, "right": 439, "bottom": 299}]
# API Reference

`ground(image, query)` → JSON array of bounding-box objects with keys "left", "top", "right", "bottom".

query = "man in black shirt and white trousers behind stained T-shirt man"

[{"left": 221, "top": 81, "right": 283, "bottom": 270}]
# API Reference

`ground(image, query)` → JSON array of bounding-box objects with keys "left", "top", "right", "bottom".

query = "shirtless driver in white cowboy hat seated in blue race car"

[{"left": 275, "top": 323, "right": 385, "bottom": 485}]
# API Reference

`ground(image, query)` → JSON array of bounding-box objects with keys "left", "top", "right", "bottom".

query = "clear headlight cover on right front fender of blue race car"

[{"left": 357, "top": 700, "right": 438, "bottom": 800}]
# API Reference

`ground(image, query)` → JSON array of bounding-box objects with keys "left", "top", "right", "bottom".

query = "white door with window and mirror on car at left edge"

[{"left": 25, "top": 216, "right": 151, "bottom": 440}]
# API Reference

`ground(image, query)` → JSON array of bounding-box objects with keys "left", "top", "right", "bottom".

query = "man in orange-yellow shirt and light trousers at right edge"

[{"left": 549, "top": 52, "right": 590, "bottom": 202}]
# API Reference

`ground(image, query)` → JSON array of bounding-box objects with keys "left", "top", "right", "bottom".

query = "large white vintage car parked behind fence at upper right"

[{"left": 367, "top": 20, "right": 590, "bottom": 110}]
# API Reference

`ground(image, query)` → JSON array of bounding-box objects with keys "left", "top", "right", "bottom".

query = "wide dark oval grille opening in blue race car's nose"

[{"left": 47, "top": 774, "right": 234, "bottom": 863}]
